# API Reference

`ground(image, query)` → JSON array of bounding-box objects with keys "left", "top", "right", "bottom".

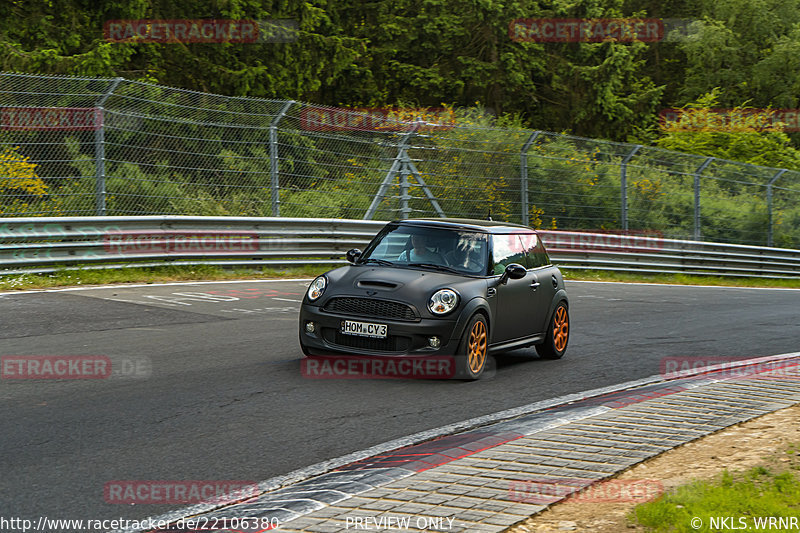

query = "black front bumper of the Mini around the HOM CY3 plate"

[{"left": 300, "top": 303, "right": 460, "bottom": 356}]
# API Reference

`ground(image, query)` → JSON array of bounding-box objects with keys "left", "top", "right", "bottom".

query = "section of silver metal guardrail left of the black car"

[{"left": 0, "top": 216, "right": 385, "bottom": 274}]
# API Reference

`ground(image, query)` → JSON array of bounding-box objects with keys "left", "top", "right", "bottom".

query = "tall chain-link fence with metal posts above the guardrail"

[{"left": 0, "top": 74, "right": 800, "bottom": 247}]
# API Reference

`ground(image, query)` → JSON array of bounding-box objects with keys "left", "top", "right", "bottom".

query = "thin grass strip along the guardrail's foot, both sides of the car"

[{"left": 0, "top": 265, "right": 800, "bottom": 291}]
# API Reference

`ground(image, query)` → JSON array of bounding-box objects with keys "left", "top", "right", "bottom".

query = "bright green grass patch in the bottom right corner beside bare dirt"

[{"left": 629, "top": 446, "right": 800, "bottom": 532}]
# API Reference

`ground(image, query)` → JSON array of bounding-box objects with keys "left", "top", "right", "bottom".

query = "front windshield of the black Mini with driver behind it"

[{"left": 360, "top": 225, "right": 488, "bottom": 275}]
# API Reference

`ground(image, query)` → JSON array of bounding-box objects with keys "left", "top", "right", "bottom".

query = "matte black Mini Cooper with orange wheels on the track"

[{"left": 300, "top": 218, "right": 569, "bottom": 379}]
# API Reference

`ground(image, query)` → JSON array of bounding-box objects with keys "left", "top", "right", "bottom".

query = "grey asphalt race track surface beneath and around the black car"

[{"left": 0, "top": 281, "right": 800, "bottom": 519}]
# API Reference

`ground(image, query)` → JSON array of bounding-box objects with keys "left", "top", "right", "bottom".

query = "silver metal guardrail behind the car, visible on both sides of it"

[{"left": 0, "top": 215, "right": 800, "bottom": 278}]
